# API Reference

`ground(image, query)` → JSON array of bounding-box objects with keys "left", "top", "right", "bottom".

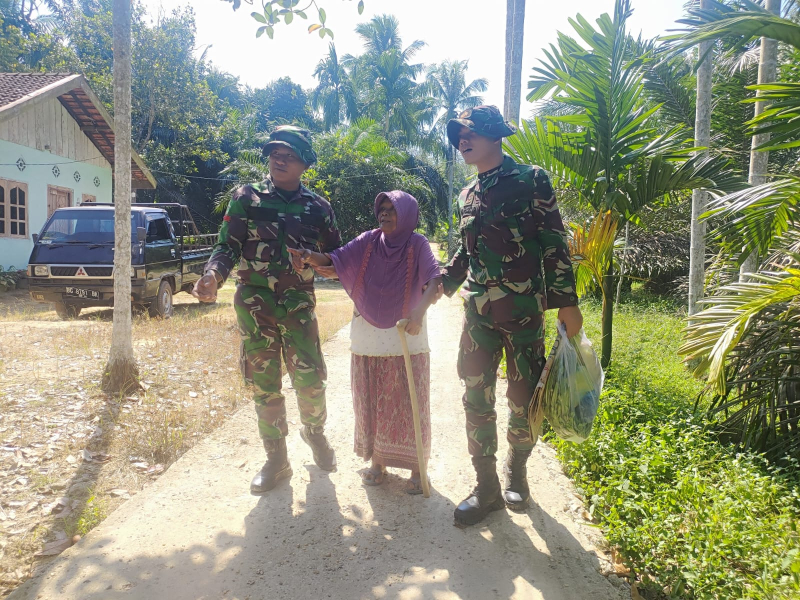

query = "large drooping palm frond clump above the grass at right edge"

[{"left": 679, "top": 262, "right": 800, "bottom": 457}]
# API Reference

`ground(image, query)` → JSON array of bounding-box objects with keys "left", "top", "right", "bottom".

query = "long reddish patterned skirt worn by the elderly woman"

[{"left": 350, "top": 353, "right": 431, "bottom": 471}]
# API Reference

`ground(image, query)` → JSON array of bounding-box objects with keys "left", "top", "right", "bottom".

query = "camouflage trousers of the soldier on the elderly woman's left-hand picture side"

[{"left": 233, "top": 285, "right": 327, "bottom": 439}]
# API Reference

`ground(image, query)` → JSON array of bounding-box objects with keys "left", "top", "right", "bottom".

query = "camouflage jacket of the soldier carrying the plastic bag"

[{"left": 442, "top": 156, "right": 578, "bottom": 323}]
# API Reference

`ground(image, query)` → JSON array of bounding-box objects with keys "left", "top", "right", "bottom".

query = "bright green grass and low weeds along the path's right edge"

[{"left": 548, "top": 293, "right": 800, "bottom": 600}]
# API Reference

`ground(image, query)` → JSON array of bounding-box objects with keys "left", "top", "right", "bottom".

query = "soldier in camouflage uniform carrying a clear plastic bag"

[{"left": 442, "top": 106, "right": 582, "bottom": 525}]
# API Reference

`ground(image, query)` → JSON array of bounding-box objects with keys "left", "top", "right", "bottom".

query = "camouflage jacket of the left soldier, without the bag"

[{"left": 206, "top": 178, "right": 341, "bottom": 299}]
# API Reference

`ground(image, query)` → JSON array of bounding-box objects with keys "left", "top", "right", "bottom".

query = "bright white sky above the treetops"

[{"left": 142, "top": 0, "right": 685, "bottom": 110}]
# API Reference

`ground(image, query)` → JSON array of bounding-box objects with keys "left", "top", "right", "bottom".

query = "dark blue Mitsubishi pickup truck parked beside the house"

[{"left": 28, "top": 203, "right": 216, "bottom": 319}]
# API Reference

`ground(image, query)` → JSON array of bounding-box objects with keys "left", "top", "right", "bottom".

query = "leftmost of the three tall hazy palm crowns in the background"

[{"left": 311, "top": 42, "right": 358, "bottom": 130}]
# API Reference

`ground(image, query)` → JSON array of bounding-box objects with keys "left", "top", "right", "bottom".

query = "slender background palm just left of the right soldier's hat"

[{"left": 428, "top": 60, "right": 489, "bottom": 253}]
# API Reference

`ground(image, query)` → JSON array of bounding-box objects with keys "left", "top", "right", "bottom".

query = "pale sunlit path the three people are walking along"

[{"left": 10, "top": 298, "right": 630, "bottom": 600}]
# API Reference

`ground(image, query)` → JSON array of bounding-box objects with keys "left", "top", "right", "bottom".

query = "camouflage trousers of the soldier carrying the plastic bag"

[{"left": 458, "top": 304, "right": 545, "bottom": 456}]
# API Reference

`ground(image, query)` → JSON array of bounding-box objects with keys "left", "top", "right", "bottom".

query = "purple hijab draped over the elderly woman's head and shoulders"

[{"left": 330, "top": 190, "right": 440, "bottom": 329}]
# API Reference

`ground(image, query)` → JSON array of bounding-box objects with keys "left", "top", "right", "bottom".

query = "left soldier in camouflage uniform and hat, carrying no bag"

[{"left": 195, "top": 125, "right": 341, "bottom": 494}]
